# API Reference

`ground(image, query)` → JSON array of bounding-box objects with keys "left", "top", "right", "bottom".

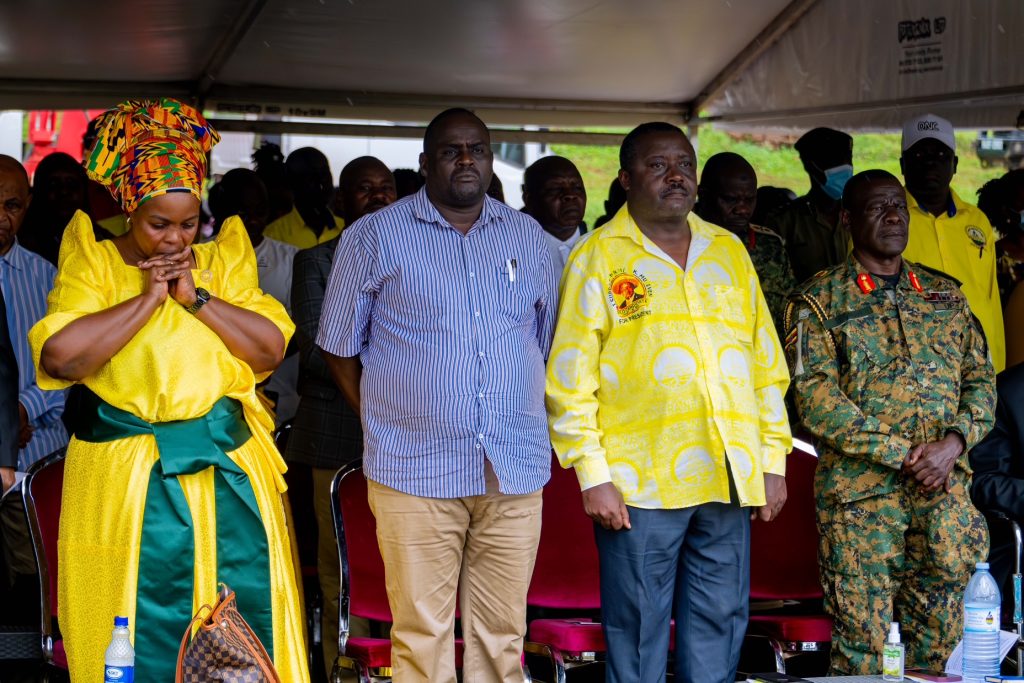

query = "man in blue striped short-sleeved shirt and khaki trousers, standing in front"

[{"left": 316, "top": 110, "right": 556, "bottom": 683}]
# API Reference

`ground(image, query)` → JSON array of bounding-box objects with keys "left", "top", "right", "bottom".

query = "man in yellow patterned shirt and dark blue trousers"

[{"left": 547, "top": 123, "right": 792, "bottom": 683}]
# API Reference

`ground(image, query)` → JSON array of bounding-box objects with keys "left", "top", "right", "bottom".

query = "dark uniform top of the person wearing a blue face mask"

[{"left": 766, "top": 195, "right": 850, "bottom": 283}]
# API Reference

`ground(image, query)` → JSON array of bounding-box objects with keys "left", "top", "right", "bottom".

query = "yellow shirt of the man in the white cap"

[{"left": 903, "top": 189, "right": 1007, "bottom": 373}]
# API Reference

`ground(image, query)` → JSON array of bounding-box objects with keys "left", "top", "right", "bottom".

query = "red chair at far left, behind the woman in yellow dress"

[{"left": 22, "top": 454, "right": 68, "bottom": 671}]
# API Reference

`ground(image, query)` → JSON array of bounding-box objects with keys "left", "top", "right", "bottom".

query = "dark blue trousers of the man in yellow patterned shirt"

[{"left": 595, "top": 503, "right": 751, "bottom": 683}]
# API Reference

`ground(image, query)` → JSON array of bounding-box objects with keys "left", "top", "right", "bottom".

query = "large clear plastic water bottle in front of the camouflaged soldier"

[{"left": 964, "top": 562, "right": 999, "bottom": 683}]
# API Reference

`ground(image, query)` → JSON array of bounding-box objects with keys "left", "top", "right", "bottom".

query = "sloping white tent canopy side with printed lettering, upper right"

[{"left": 708, "top": 0, "right": 1024, "bottom": 128}]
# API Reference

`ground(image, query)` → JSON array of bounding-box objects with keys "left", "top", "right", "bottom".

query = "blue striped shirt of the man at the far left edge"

[{"left": 0, "top": 242, "right": 68, "bottom": 471}]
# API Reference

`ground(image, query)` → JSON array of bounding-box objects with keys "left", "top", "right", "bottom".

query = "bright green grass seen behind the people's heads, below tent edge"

[{"left": 551, "top": 127, "right": 1006, "bottom": 225}]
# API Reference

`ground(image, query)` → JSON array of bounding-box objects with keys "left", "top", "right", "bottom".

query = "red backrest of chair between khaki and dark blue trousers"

[{"left": 526, "top": 457, "right": 601, "bottom": 609}]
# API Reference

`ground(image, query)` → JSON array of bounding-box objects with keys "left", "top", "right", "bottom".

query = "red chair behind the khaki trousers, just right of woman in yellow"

[{"left": 331, "top": 460, "right": 463, "bottom": 683}]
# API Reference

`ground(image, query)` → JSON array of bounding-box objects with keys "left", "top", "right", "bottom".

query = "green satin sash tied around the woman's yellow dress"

[{"left": 75, "top": 391, "right": 273, "bottom": 681}]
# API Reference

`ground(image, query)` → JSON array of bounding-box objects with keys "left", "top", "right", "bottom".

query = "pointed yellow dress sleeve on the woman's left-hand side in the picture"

[{"left": 29, "top": 211, "right": 113, "bottom": 389}]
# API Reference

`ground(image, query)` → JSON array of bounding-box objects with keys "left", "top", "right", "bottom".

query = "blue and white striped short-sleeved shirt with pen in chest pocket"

[{"left": 316, "top": 189, "right": 557, "bottom": 498}]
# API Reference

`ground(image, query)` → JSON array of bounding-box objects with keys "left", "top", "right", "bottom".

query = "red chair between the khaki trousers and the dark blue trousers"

[{"left": 524, "top": 457, "right": 676, "bottom": 683}]
